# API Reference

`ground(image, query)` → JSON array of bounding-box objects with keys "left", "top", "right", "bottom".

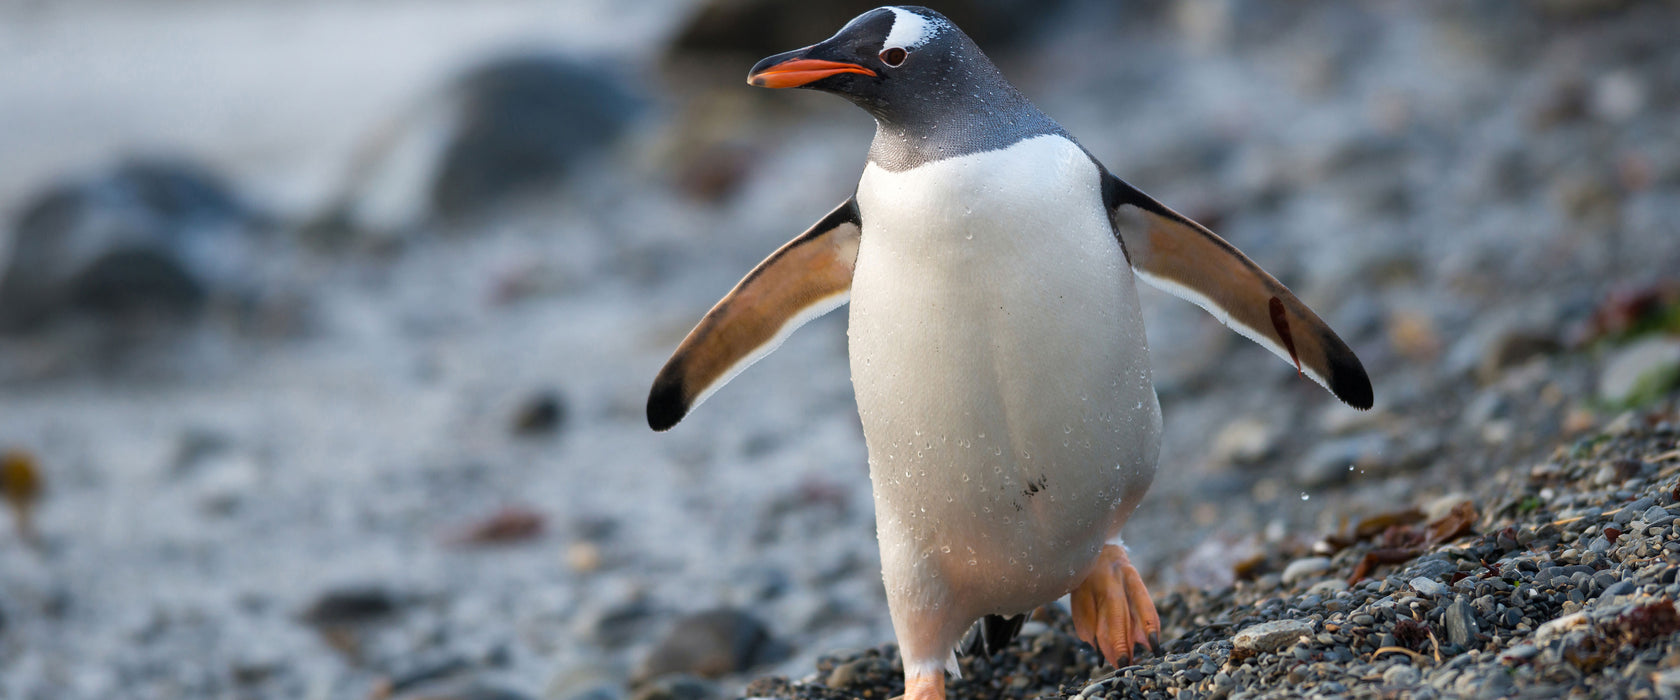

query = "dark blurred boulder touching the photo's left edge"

[{"left": 0, "top": 159, "right": 265, "bottom": 332}]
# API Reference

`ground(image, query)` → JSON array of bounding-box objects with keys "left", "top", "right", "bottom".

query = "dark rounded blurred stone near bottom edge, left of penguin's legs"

[{"left": 633, "top": 608, "right": 788, "bottom": 683}]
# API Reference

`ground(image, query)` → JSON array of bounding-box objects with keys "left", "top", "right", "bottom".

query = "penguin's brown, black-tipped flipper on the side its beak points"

[{"left": 647, "top": 198, "right": 864, "bottom": 430}]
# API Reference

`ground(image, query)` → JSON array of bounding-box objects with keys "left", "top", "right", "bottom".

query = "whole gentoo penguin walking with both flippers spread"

[{"left": 647, "top": 7, "right": 1371, "bottom": 700}]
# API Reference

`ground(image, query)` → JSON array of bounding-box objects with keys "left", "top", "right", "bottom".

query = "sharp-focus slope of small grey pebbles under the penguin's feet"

[{"left": 746, "top": 402, "right": 1680, "bottom": 700}]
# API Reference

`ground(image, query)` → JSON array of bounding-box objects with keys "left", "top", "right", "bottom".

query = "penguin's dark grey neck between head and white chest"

[{"left": 864, "top": 65, "right": 1067, "bottom": 173}]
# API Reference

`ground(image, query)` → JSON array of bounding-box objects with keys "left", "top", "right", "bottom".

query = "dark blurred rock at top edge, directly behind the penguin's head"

[{"left": 670, "top": 0, "right": 1068, "bottom": 60}]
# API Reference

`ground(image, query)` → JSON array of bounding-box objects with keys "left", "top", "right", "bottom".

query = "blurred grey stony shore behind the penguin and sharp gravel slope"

[{"left": 0, "top": 0, "right": 1680, "bottom": 700}]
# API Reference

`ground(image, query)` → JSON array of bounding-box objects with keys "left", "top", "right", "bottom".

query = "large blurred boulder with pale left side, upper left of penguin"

[{"left": 324, "top": 54, "right": 642, "bottom": 240}]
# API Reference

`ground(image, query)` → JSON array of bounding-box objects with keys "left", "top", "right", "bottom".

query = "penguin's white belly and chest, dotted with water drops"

[{"left": 848, "top": 136, "right": 1161, "bottom": 624}]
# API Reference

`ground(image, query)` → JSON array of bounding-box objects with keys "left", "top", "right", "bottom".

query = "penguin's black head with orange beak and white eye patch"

[{"left": 746, "top": 7, "right": 996, "bottom": 121}]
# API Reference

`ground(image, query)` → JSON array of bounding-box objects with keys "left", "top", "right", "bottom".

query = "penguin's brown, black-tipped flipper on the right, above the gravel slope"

[{"left": 1102, "top": 171, "right": 1371, "bottom": 410}]
